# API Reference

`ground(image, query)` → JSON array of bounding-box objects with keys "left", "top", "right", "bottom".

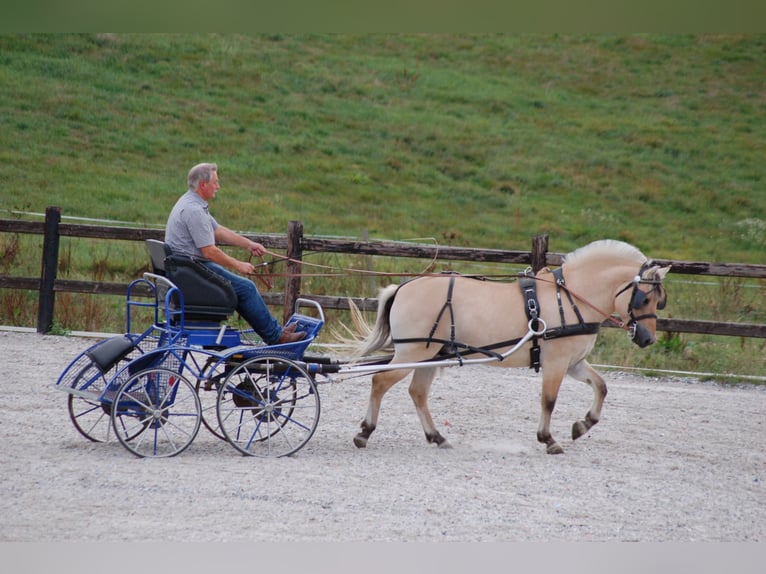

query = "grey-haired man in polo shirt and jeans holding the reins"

[{"left": 165, "top": 163, "right": 306, "bottom": 345}]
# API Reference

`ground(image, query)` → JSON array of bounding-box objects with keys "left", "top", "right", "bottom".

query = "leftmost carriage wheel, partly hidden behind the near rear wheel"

[{"left": 67, "top": 361, "right": 139, "bottom": 442}]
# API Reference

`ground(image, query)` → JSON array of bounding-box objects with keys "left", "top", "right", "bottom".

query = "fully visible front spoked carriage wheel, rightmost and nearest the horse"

[{"left": 218, "top": 357, "right": 319, "bottom": 457}]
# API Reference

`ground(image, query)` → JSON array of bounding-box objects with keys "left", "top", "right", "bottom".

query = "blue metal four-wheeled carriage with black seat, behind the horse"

[{"left": 56, "top": 240, "right": 325, "bottom": 457}]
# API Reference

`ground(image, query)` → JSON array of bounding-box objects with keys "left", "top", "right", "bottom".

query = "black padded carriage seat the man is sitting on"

[{"left": 146, "top": 239, "right": 237, "bottom": 322}]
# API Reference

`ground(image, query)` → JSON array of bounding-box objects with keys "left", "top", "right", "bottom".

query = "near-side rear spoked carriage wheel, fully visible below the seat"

[{"left": 111, "top": 368, "right": 202, "bottom": 458}]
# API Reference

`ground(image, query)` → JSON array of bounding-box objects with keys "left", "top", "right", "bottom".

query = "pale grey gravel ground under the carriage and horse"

[{"left": 0, "top": 332, "right": 766, "bottom": 542}]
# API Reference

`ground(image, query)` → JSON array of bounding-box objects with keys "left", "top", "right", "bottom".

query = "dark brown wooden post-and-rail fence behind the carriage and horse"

[{"left": 0, "top": 207, "right": 766, "bottom": 338}]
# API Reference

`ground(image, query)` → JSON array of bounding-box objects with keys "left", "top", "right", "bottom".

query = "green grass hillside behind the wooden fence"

[{"left": 0, "top": 34, "right": 766, "bottom": 382}]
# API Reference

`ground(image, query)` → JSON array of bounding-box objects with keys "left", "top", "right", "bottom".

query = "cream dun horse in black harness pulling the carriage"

[{"left": 354, "top": 239, "right": 670, "bottom": 454}]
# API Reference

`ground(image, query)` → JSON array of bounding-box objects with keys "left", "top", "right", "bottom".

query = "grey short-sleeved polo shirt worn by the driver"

[{"left": 165, "top": 190, "right": 218, "bottom": 257}]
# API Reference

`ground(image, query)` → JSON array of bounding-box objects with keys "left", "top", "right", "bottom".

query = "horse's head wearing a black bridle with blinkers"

[{"left": 615, "top": 262, "right": 670, "bottom": 348}]
